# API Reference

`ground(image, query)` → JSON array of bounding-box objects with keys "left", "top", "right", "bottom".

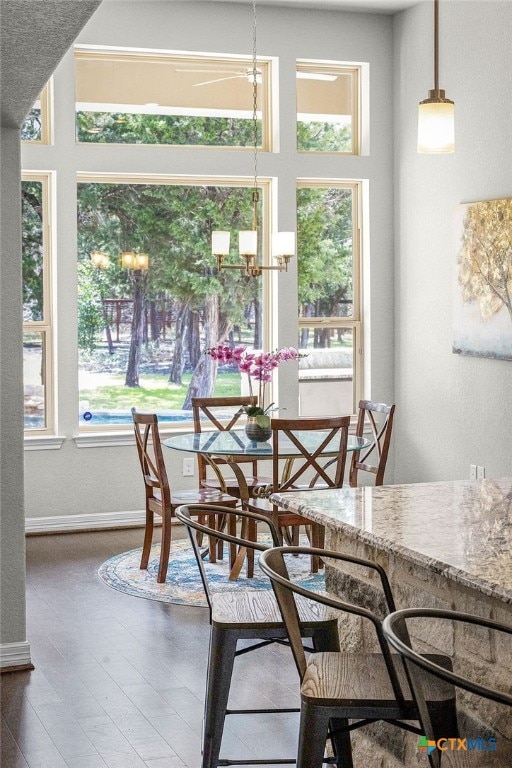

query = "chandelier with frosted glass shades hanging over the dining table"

[{"left": 212, "top": 0, "right": 295, "bottom": 277}]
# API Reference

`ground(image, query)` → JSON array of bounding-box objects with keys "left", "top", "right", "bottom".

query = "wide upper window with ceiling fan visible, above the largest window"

[{"left": 75, "top": 49, "right": 270, "bottom": 149}]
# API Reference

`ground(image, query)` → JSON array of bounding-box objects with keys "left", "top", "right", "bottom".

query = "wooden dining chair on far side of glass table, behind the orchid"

[{"left": 192, "top": 395, "right": 271, "bottom": 498}]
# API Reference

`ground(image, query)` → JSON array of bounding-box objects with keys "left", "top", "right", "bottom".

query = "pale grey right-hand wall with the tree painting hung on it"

[{"left": 394, "top": 1, "right": 512, "bottom": 482}]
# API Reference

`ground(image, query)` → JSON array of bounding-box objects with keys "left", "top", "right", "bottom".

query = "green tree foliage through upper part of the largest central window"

[{"left": 78, "top": 184, "right": 258, "bottom": 330}]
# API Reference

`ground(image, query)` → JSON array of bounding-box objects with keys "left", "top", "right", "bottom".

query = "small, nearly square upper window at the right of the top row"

[{"left": 297, "top": 61, "right": 361, "bottom": 155}]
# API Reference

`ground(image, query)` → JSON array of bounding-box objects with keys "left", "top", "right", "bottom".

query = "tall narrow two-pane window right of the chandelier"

[{"left": 297, "top": 180, "right": 362, "bottom": 416}]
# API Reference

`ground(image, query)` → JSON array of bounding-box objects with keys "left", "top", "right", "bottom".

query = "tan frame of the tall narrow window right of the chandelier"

[{"left": 297, "top": 178, "right": 364, "bottom": 416}]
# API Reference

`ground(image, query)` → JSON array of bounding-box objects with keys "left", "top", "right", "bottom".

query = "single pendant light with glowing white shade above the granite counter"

[{"left": 418, "top": 0, "right": 455, "bottom": 154}]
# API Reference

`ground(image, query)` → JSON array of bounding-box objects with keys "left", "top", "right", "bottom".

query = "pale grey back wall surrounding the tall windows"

[{"left": 23, "top": 2, "right": 394, "bottom": 518}]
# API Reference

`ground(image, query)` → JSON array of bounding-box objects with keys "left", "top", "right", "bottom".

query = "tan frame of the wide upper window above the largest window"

[{"left": 74, "top": 45, "right": 274, "bottom": 152}]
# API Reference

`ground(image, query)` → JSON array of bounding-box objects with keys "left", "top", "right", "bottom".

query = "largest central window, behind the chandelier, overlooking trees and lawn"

[{"left": 78, "top": 176, "right": 268, "bottom": 428}]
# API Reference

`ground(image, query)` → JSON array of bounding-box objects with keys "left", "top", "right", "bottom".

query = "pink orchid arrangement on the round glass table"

[{"left": 206, "top": 343, "right": 305, "bottom": 428}]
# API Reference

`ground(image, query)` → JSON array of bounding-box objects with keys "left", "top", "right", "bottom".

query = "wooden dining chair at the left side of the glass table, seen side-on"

[{"left": 132, "top": 408, "right": 237, "bottom": 584}]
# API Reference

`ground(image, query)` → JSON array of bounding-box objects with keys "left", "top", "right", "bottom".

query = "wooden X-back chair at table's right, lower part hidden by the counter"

[{"left": 349, "top": 400, "right": 395, "bottom": 488}]
